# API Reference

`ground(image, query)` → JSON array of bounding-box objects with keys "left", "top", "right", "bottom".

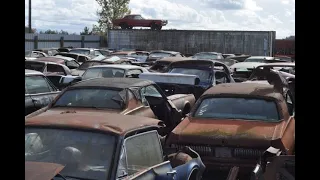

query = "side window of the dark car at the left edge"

[{"left": 25, "top": 76, "right": 53, "bottom": 94}]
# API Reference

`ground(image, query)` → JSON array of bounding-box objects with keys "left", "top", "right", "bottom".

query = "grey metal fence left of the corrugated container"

[{"left": 25, "top": 34, "right": 107, "bottom": 51}]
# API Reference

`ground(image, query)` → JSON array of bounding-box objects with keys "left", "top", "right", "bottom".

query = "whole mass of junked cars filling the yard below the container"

[{"left": 25, "top": 48, "right": 295, "bottom": 180}]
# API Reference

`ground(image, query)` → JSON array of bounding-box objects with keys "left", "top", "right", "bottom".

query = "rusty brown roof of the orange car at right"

[{"left": 201, "top": 82, "right": 283, "bottom": 100}]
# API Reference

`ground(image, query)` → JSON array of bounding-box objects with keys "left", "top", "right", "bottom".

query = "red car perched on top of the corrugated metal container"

[{"left": 112, "top": 14, "right": 168, "bottom": 30}]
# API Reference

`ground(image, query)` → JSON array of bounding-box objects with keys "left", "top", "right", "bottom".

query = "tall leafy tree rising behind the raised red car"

[{"left": 96, "top": 0, "right": 131, "bottom": 32}]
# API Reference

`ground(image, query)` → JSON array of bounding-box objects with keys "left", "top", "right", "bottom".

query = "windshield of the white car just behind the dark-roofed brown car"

[{"left": 82, "top": 67, "right": 125, "bottom": 80}]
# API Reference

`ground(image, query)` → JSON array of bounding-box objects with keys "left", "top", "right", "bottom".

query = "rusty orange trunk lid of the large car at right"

[{"left": 169, "top": 118, "right": 285, "bottom": 146}]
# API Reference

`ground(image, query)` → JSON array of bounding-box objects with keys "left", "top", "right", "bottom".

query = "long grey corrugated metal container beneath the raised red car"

[{"left": 108, "top": 30, "right": 276, "bottom": 55}]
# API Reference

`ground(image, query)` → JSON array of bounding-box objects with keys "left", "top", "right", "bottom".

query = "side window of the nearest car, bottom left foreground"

[{"left": 118, "top": 131, "right": 163, "bottom": 175}]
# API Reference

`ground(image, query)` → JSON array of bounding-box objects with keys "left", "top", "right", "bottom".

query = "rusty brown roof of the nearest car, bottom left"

[{"left": 25, "top": 111, "right": 161, "bottom": 135}]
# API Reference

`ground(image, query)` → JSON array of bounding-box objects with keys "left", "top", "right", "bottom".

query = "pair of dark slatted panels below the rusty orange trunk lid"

[{"left": 171, "top": 144, "right": 265, "bottom": 159}]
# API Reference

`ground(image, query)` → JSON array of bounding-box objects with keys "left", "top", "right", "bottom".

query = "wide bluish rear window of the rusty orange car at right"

[{"left": 194, "top": 97, "right": 280, "bottom": 121}]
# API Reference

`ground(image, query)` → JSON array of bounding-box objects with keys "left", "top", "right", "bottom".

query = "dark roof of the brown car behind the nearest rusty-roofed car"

[{"left": 70, "top": 78, "right": 154, "bottom": 89}]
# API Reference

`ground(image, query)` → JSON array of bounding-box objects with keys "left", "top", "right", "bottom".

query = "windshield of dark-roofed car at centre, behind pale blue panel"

[{"left": 170, "top": 68, "right": 211, "bottom": 82}]
